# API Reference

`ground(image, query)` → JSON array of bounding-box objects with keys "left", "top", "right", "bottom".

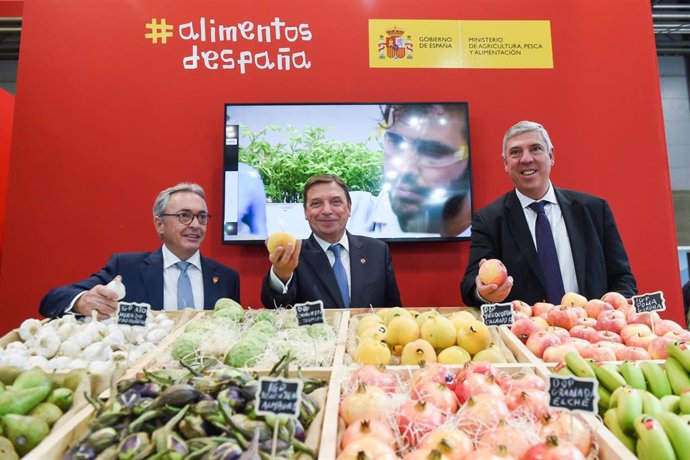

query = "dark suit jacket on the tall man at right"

[{"left": 460, "top": 187, "right": 637, "bottom": 306}]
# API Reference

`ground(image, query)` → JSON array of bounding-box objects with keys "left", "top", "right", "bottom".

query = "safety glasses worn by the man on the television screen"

[{"left": 384, "top": 131, "right": 468, "bottom": 168}]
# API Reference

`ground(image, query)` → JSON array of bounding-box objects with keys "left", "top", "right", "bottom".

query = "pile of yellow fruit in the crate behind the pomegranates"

[{"left": 348, "top": 307, "right": 506, "bottom": 365}]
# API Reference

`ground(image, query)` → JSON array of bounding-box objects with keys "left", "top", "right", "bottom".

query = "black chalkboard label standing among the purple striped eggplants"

[{"left": 256, "top": 377, "right": 303, "bottom": 417}]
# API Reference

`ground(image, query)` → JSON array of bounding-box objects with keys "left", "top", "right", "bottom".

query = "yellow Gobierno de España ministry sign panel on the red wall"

[{"left": 369, "top": 19, "right": 553, "bottom": 69}]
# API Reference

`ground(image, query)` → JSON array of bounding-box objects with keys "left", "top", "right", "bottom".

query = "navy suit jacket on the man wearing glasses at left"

[{"left": 39, "top": 249, "right": 240, "bottom": 317}]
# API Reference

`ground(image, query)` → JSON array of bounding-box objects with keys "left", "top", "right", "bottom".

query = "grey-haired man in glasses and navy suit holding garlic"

[{"left": 40, "top": 183, "right": 240, "bottom": 317}]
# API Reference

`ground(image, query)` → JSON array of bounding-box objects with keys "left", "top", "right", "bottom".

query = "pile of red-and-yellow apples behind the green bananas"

[{"left": 511, "top": 292, "right": 690, "bottom": 362}]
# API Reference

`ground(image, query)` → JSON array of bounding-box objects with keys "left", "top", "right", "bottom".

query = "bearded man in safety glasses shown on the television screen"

[{"left": 351, "top": 104, "right": 471, "bottom": 236}]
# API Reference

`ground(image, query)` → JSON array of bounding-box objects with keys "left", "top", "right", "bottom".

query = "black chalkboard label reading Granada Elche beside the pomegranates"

[{"left": 549, "top": 375, "right": 599, "bottom": 414}]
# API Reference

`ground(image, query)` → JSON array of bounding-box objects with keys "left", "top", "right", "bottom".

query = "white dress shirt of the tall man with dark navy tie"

[{"left": 515, "top": 181, "right": 578, "bottom": 292}]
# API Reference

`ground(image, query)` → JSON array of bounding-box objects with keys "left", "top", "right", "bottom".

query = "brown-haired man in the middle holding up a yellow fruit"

[{"left": 261, "top": 175, "right": 401, "bottom": 308}]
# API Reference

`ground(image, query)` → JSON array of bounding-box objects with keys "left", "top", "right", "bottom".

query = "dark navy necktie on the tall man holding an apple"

[{"left": 529, "top": 201, "right": 565, "bottom": 305}]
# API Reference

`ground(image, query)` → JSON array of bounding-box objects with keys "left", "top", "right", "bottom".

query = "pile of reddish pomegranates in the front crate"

[{"left": 338, "top": 362, "right": 596, "bottom": 460}]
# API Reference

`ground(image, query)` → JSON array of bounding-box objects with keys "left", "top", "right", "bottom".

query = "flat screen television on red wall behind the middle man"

[{"left": 222, "top": 102, "right": 473, "bottom": 243}]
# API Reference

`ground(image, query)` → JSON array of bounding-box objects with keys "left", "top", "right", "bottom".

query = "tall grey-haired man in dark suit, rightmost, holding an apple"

[{"left": 460, "top": 121, "right": 637, "bottom": 306}]
